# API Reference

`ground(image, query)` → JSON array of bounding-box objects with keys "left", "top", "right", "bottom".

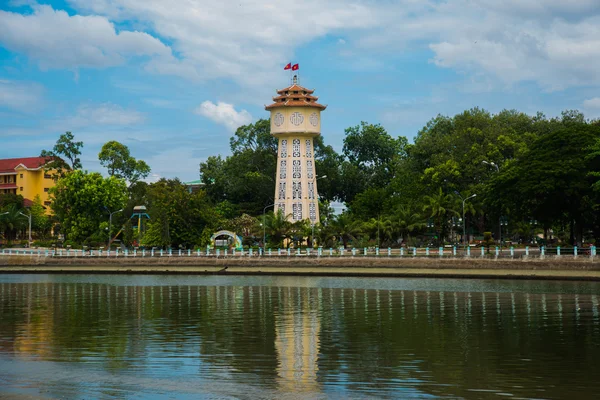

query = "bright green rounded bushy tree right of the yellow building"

[{"left": 49, "top": 170, "right": 127, "bottom": 243}]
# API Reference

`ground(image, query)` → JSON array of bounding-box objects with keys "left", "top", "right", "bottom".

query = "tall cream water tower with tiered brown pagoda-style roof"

[{"left": 265, "top": 76, "right": 326, "bottom": 224}]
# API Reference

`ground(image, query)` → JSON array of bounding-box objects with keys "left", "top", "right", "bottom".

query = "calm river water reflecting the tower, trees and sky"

[{"left": 0, "top": 277, "right": 600, "bottom": 398}]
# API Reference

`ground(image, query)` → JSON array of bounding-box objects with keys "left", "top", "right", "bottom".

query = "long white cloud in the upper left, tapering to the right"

[{"left": 0, "top": 6, "right": 171, "bottom": 69}]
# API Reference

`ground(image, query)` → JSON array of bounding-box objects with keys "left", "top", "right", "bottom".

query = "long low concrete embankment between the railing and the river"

[{"left": 0, "top": 255, "right": 600, "bottom": 281}]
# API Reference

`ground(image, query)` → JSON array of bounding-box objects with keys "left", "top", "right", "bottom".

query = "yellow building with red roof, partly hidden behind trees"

[{"left": 0, "top": 157, "right": 54, "bottom": 212}]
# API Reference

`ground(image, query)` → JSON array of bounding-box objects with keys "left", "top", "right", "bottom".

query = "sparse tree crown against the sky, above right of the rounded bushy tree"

[{"left": 98, "top": 140, "right": 150, "bottom": 185}]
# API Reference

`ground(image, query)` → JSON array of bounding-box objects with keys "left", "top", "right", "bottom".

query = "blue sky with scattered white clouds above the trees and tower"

[{"left": 0, "top": 0, "right": 600, "bottom": 180}]
